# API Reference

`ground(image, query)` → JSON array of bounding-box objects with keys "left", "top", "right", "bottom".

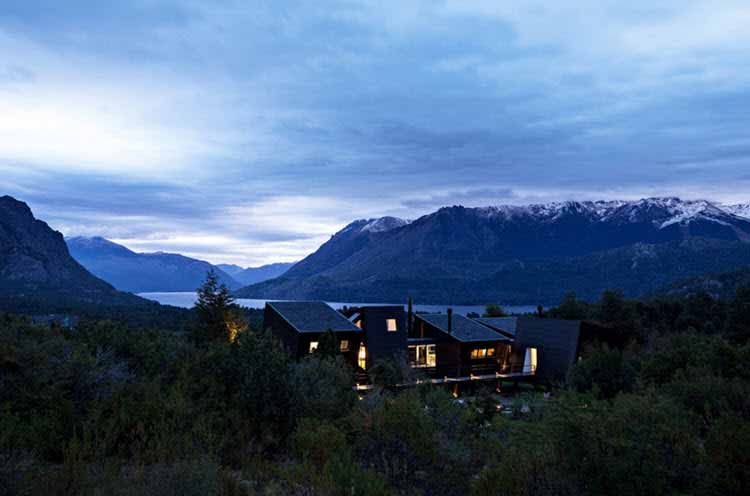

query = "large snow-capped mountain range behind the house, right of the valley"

[{"left": 236, "top": 198, "right": 750, "bottom": 304}]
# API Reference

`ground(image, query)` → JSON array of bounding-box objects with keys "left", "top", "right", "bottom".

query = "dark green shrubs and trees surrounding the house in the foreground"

[{"left": 0, "top": 280, "right": 750, "bottom": 495}]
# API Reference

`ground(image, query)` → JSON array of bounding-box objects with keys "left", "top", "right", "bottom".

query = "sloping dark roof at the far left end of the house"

[{"left": 266, "top": 301, "right": 361, "bottom": 332}]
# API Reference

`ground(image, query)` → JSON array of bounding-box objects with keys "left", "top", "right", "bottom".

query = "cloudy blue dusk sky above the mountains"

[{"left": 0, "top": 0, "right": 750, "bottom": 266}]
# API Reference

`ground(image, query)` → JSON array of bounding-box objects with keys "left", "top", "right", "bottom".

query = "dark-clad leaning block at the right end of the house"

[{"left": 512, "top": 317, "right": 581, "bottom": 381}]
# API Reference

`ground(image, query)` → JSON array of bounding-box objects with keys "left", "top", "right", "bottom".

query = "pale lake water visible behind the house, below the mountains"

[{"left": 138, "top": 292, "right": 536, "bottom": 315}]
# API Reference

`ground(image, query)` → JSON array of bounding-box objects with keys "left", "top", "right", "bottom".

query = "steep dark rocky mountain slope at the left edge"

[{"left": 0, "top": 196, "right": 146, "bottom": 309}]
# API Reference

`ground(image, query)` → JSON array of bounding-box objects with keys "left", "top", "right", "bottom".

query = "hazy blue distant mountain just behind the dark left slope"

[{"left": 66, "top": 237, "right": 241, "bottom": 293}]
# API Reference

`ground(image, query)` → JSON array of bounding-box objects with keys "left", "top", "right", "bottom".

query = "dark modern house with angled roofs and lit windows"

[{"left": 264, "top": 301, "right": 582, "bottom": 383}]
